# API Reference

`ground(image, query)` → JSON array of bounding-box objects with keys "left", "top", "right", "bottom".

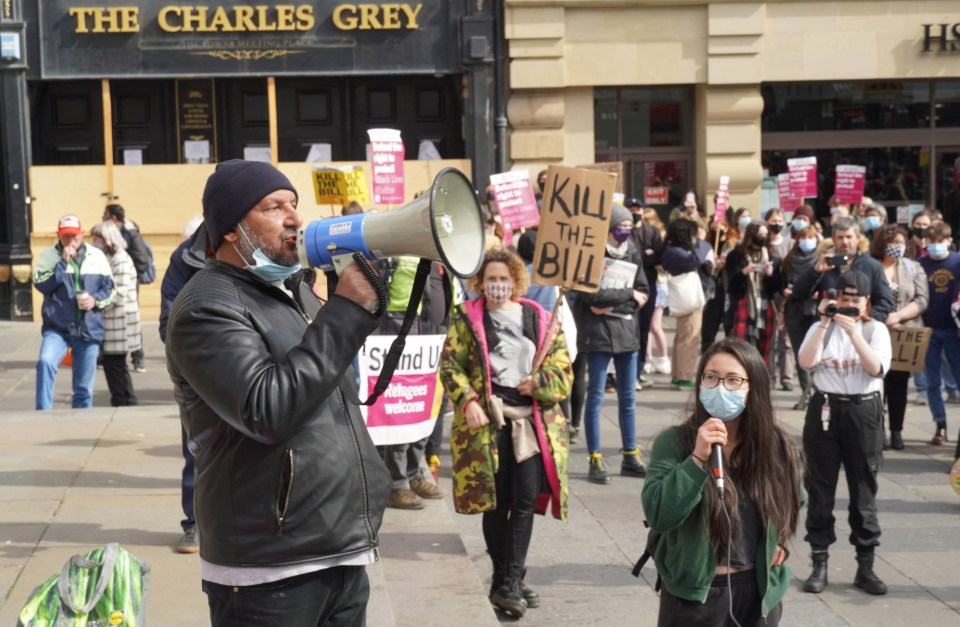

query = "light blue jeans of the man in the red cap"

[{"left": 37, "top": 331, "right": 100, "bottom": 409}]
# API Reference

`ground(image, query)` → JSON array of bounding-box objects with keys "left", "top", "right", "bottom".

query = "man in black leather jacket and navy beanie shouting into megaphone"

[{"left": 166, "top": 160, "right": 391, "bottom": 627}]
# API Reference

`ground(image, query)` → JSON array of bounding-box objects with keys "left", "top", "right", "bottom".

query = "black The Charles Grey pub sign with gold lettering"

[{"left": 40, "top": 0, "right": 460, "bottom": 78}]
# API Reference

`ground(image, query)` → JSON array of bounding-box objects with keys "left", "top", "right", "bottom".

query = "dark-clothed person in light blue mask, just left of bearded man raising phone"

[{"left": 780, "top": 228, "right": 820, "bottom": 400}]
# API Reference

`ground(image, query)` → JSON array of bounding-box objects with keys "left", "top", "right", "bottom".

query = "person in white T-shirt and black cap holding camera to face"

[{"left": 799, "top": 270, "right": 892, "bottom": 594}]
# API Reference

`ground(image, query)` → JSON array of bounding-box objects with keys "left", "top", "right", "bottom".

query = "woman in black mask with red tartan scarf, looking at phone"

[{"left": 724, "top": 222, "right": 780, "bottom": 363}]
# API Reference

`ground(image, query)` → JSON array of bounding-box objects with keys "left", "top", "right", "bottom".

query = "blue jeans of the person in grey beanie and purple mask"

[{"left": 583, "top": 352, "right": 637, "bottom": 453}]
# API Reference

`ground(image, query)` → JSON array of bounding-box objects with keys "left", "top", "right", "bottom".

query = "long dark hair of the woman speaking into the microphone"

[{"left": 680, "top": 338, "right": 801, "bottom": 557}]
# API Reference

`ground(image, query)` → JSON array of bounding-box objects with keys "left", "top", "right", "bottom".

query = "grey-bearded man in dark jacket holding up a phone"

[{"left": 793, "top": 217, "right": 894, "bottom": 322}]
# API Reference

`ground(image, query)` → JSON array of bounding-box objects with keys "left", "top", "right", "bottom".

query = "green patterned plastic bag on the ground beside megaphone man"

[{"left": 20, "top": 543, "right": 150, "bottom": 627}]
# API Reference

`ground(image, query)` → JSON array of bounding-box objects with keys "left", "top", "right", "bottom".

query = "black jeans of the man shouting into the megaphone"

[{"left": 203, "top": 566, "right": 370, "bottom": 627}]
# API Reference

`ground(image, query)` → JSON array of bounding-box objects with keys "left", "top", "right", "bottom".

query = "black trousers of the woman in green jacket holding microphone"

[{"left": 657, "top": 570, "right": 783, "bottom": 627}]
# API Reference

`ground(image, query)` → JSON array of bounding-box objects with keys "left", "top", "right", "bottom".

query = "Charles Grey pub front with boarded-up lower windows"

[{"left": 0, "top": 0, "right": 505, "bottom": 319}]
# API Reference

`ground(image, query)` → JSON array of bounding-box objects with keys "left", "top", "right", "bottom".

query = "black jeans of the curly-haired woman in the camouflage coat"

[{"left": 483, "top": 420, "right": 543, "bottom": 569}]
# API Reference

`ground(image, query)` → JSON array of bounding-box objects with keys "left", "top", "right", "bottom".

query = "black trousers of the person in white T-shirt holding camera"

[{"left": 803, "top": 392, "right": 883, "bottom": 553}]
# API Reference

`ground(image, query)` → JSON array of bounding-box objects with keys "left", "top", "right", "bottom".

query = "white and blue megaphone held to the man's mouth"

[{"left": 297, "top": 168, "right": 484, "bottom": 278}]
